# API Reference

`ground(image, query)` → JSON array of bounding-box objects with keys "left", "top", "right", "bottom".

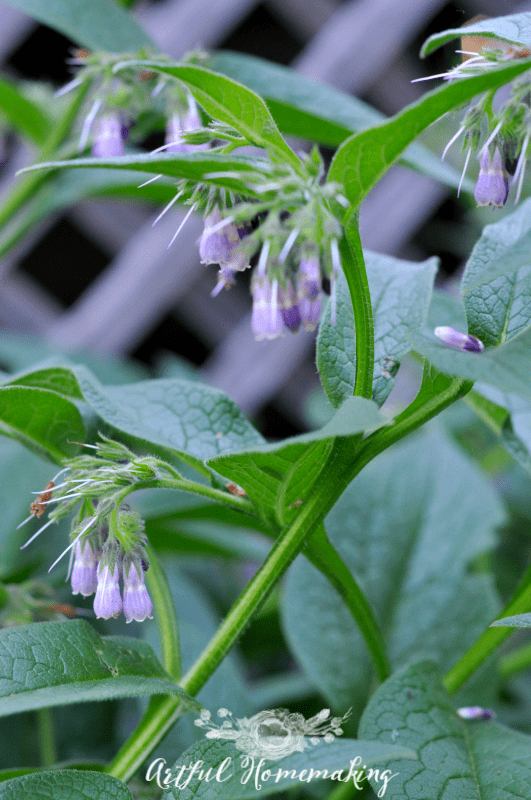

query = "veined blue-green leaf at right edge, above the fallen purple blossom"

[{"left": 461, "top": 199, "right": 531, "bottom": 345}]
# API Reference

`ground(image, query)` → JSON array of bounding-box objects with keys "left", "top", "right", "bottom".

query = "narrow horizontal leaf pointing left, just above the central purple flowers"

[{"left": 19, "top": 150, "right": 267, "bottom": 195}]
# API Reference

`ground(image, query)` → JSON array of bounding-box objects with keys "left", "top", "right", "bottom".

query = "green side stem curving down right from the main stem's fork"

[{"left": 304, "top": 525, "right": 391, "bottom": 681}]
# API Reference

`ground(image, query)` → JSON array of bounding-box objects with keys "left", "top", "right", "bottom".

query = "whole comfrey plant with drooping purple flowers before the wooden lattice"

[{"left": 6, "top": 6, "right": 531, "bottom": 800}]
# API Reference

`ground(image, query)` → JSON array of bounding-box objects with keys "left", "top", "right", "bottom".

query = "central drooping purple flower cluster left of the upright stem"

[{"left": 162, "top": 145, "right": 348, "bottom": 341}]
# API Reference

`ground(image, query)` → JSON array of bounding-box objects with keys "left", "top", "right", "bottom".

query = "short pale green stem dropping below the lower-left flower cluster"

[{"left": 146, "top": 546, "right": 181, "bottom": 681}]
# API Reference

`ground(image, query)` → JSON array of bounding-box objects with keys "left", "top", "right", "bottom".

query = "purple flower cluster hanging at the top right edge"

[{"left": 420, "top": 46, "right": 531, "bottom": 208}]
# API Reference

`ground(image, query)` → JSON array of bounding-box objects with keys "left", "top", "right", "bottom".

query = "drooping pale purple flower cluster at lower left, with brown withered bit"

[{"left": 15, "top": 434, "right": 180, "bottom": 622}]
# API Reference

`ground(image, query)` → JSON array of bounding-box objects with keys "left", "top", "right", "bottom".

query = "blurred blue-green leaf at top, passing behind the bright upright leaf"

[{"left": 208, "top": 51, "right": 474, "bottom": 191}]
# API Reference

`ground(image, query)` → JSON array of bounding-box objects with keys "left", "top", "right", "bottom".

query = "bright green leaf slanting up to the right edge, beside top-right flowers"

[{"left": 328, "top": 58, "right": 531, "bottom": 206}]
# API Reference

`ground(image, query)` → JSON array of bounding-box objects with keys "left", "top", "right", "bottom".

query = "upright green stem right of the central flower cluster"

[{"left": 340, "top": 209, "right": 374, "bottom": 398}]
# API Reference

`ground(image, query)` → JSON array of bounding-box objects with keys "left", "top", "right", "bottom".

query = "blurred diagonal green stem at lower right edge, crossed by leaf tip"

[{"left": 444, "top": 567, "right": 531, "bottom": 692}]
